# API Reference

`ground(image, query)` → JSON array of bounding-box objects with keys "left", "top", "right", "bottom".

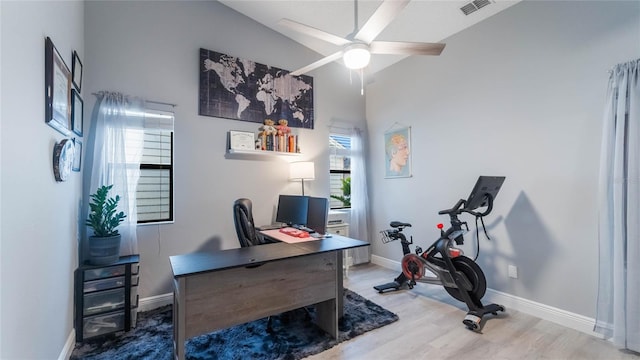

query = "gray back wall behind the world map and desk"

[{"left": 85, "top": 1, "right": 365, "bottom": 298}]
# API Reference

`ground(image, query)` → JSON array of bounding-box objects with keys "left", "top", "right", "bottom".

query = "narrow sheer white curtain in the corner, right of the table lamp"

[{"left": 349, "top": 128, "right": 371, "bottom": 264}]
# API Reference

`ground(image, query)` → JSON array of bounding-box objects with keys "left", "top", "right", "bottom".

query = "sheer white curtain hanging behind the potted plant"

[{"left": 83, "top": 92, "right": 144, "bottom": 255}]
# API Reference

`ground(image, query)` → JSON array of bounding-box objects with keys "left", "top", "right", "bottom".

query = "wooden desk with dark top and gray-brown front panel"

[{"left": 169, "top": 236, "right": 369, "bottom": 359}]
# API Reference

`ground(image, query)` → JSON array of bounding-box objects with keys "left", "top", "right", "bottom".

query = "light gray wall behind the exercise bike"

[{"left": 366, "top": 1, "right": 640, "bottom": 317}]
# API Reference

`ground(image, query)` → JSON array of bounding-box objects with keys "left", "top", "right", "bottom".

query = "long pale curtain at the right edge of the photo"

[{"left": 595, "top": 59, "right": 640, "bottom": 351}]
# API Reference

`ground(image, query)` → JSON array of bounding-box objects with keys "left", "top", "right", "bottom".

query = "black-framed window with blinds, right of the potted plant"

[{"left": 126, "top": 108, "right": 174, "bottom": 224}]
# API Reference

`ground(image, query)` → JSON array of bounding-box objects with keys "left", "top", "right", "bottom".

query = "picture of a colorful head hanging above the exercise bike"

[{"left": 384, "top": 127, "right": 411, "bottom": 178}]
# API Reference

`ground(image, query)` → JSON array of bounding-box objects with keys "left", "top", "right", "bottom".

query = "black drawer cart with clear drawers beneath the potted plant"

[{"left": 74, "top": 255, "right": 140, "bottom": 342}]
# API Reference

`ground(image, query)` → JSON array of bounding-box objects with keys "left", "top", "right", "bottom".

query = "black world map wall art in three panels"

[{"left": 198, "top": 49, "right": 314, "bottom": 129}]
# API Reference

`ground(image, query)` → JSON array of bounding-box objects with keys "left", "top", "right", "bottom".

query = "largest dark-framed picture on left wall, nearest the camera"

[{"left": 44, "top": 37, "right": 71, "bottom": 135}]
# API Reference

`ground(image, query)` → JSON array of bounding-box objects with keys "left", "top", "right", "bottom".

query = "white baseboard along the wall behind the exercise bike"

[{"left": 371, "top": 255, "right": 602, "bottom": 338}]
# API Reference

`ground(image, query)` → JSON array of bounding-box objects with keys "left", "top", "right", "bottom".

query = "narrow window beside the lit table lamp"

[{"left": 329, "top": 134, "right": 351, "bottom": 209}]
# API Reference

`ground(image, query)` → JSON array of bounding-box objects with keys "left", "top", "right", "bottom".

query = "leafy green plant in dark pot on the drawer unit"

[{"left": 85, "top": 185, "right": 127, "bottom": 265}]
